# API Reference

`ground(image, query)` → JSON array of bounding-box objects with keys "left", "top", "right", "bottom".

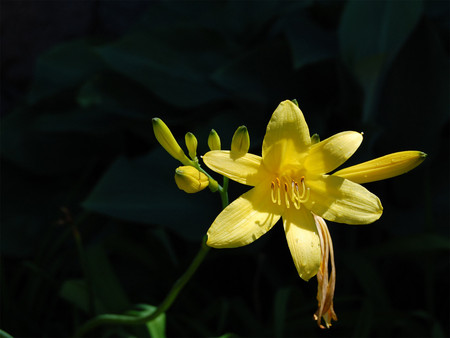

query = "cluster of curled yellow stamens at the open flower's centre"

[{"left": 270, "top": 176, "right": 310, "bottom": 209}]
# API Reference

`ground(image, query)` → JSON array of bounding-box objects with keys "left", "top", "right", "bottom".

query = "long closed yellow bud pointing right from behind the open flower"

[{"left": 333, "top": 151, "right": 427, "bottom": 183}]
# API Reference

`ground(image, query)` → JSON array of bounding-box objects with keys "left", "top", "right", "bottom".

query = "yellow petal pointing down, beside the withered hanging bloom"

[{"left": 283, "top": 208, "right": 322, "bottom": 281}]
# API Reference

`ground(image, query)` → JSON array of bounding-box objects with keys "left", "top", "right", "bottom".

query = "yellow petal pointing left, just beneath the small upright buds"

[{"left": 203, "top": 150, "right": 270, "bottom": 186}]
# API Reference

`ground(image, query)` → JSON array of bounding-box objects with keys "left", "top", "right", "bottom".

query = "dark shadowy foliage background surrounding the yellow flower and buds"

[{"left": 0, "top": 0, "right": 450, "bottom": 337}]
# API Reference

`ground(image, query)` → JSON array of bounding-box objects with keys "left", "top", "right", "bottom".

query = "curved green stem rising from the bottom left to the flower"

[{"left": 74, "top": 178, "right": 228, "bottom": 337}]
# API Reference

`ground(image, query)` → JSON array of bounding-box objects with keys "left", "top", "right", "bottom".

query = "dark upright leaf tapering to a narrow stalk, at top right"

[{"left": 339, "top": 0, "right": 423, "bottom": 122}]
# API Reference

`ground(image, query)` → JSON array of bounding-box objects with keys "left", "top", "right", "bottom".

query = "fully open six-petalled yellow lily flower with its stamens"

[{"left": 203, "top": 101, "right": 383, "bottom": 280}]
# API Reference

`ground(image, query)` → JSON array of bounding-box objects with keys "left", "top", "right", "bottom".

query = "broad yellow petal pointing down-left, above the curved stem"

[{"left": 206, "top": 182, "right": 282, "bottom": 248}]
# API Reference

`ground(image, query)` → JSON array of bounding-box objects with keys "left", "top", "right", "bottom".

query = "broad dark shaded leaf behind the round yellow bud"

[{"left": 83, "top": 147, "right": 220, "bottom": 240}]
